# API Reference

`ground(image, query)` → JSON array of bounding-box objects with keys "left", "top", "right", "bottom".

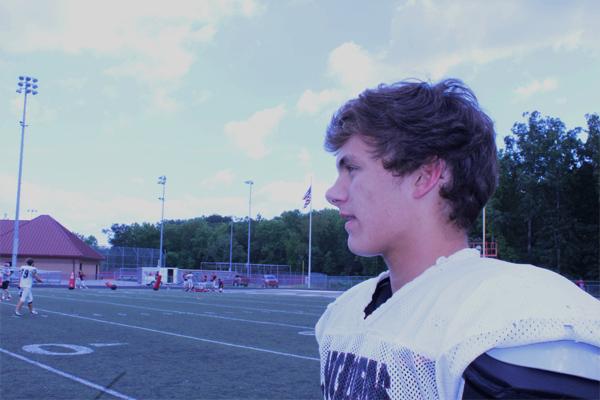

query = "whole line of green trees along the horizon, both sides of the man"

[{"left": 97, "top": 112, "right": 600, "bottom": 280}]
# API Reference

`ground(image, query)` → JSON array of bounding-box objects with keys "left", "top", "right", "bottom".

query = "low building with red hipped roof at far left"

[{"left": 0, "top": 215, "right": 104, "bottom": 279}]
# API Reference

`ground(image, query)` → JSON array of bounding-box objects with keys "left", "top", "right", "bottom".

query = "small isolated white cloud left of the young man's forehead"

[{"left": 224, "top": 104, "right": 286, "bottom": 159}]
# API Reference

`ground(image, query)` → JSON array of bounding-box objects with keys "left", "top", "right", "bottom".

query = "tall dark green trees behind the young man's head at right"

[{"left": 490, "top": 112, "right": 598, "bottom": 276}]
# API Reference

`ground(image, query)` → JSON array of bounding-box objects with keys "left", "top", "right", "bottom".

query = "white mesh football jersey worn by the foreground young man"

[{"left": 315, "top": 249, "right": 600, "bottom": 399}]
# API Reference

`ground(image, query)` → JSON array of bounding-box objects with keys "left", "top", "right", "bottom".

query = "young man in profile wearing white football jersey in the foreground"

[{"left": 316, "top": 80, "right": 600, "bottom": 399}]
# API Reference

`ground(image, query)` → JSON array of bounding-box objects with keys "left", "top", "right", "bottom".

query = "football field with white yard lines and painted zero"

[{"left": 0, "top": 287, "right": 336, "bottom": 400}]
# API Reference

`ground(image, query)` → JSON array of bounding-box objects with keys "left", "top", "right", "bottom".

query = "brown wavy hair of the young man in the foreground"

[{"left": 325, "top": 79, "right": 498, "bottom": 230}]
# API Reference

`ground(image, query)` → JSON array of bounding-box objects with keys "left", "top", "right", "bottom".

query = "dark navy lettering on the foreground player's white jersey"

[{"left": 321, "top": 351, "right": 391, "bottom": 400}]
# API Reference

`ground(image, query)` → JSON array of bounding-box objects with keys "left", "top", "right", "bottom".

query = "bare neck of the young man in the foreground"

[{"left": 384, "top": 232, "right": 468, "bottom": 293}]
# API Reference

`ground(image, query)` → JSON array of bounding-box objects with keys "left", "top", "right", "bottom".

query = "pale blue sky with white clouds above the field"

[{"left": 0, "top": 0, "right": 600, "bottom": 244}]
